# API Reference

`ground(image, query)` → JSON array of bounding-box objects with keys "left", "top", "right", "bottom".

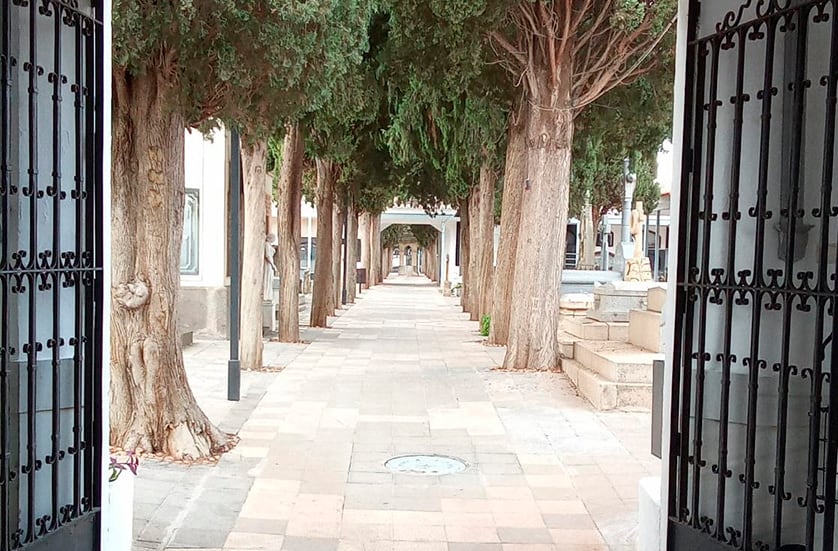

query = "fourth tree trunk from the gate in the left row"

[{"left": 309, "top": 159, "right": 336, "bottom": 327}]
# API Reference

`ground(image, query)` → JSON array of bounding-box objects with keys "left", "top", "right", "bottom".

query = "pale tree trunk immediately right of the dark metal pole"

[{"left": 240, "top": 136, "right": 268, "bottom": 370}]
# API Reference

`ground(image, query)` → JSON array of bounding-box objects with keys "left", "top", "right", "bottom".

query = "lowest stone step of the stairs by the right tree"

[{"left": 562, "top": 360, "right": 652, "bottom": 410}]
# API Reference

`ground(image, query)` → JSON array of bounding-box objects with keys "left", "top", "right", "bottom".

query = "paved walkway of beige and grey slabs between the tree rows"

[{"left": 135, "top": 278, "right": 660, "bottom": 551}]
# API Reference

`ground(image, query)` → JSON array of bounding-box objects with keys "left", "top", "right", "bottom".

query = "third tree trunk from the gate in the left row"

[{"left": 277, "top": 125, "right": 304, "bottom": 342}]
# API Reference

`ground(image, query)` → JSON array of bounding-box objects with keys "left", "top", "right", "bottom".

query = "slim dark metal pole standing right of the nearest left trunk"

[{"left": 227, "top": 128, "right": 241, "bottom": 402}]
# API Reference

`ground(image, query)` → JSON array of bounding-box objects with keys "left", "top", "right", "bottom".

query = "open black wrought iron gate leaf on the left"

[{"left": 0, "top": 0, "right": 106, "bottom": 551}]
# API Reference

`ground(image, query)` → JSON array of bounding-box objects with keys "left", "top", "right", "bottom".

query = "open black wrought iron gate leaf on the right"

[{"left": 668, "top": 0, "right": 838, "bottom": 551}]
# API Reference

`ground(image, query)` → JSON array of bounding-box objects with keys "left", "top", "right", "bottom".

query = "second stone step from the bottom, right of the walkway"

[{"left": 573, "top": 341, "right": 663, "bottom": 384}]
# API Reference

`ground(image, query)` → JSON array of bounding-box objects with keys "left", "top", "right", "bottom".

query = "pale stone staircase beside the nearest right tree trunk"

[{"left": 560, "top": 289, "right": 665, "bottom": 410}]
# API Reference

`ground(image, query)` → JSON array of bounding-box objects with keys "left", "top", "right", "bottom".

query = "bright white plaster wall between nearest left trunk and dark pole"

[{"left": 180, "top": 128, "right": 228, "bottom": 287}]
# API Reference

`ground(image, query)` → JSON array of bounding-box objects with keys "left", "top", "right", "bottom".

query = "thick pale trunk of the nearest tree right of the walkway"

[{"left": 503, "top": 72, "right": 573, "bottom": 370}]
